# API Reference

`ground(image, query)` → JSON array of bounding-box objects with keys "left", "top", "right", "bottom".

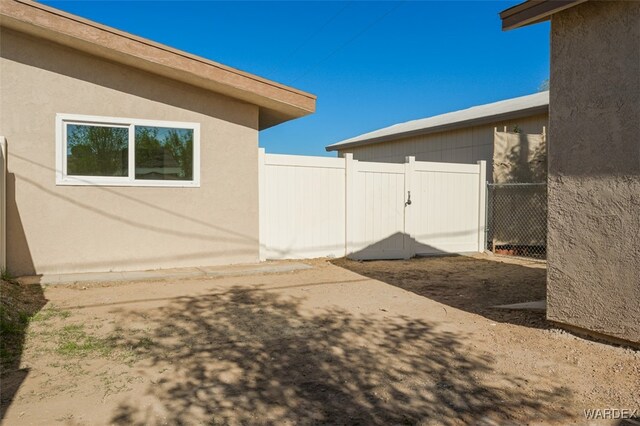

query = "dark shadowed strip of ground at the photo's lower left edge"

[{"left": 0, "top": 280, "right": 47, "bottom": 420}]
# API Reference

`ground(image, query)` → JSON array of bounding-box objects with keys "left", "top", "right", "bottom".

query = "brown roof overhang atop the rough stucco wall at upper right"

[{"left": 500, "top": 0, "right": 587, "bottom": 30}]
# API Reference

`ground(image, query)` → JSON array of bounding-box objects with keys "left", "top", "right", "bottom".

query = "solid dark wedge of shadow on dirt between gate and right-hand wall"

[{"left": 332, "top": 255, "right": 553, "bottom": 329}]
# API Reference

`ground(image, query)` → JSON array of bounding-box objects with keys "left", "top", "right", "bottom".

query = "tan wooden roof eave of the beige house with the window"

[{"left": 0, "top": 0, "right": 316, "bottom": 130}]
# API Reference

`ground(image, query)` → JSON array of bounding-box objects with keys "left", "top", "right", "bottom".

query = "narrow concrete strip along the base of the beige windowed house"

[{"left": 18, "top": 262, "right": 312, "bottom": 285}]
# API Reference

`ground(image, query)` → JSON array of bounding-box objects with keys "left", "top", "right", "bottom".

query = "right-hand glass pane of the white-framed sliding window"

[{"left": 136, "top": 126, "right": 193, "bottom": 180}]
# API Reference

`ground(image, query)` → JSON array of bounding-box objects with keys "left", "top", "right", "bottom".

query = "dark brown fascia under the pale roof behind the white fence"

[{"left": 325, "top": 105, "right": 549, "bottom": 152}]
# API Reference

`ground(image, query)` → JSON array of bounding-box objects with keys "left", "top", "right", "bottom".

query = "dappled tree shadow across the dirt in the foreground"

[{"left": 111, "top": 287, "right": 570, "bottom": 425}]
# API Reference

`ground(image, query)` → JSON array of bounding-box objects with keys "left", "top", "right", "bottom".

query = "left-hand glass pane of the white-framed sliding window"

[{"left": 67, "top": 124, "right": 129, "bottom": 176}]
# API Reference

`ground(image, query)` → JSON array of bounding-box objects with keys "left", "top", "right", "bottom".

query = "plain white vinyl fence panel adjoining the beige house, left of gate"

[{"left": 259, "top": 153, "right": 346, "bottom": 260}]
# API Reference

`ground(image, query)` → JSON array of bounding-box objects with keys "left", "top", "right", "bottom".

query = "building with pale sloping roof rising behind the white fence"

[{"left": 326, "top": 91, "right": 549, "bottom": 181}]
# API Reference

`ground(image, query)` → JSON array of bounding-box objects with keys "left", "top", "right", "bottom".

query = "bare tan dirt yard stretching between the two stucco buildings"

[{"left": 2, "top": 255, "right": 640, "bottom": 425}]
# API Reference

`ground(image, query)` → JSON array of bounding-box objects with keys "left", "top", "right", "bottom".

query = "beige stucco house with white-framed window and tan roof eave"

[{"left": 0, "top": 0, "right": 315, "bottom": 275}]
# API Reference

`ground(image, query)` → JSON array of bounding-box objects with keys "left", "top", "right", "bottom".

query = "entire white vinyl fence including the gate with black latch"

[{"left": 260, "top": 149, "right": 486, "bottom": 260}]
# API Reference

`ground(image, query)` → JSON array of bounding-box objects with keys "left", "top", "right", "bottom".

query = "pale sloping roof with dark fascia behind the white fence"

[{"left": 326, "top": 91, "right": 549, "bottom": 151}]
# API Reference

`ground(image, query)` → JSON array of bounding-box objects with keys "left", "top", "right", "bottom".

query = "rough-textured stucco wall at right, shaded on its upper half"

[{"left": 547, "top": 2, "right": 640, "bottom": 342}]
